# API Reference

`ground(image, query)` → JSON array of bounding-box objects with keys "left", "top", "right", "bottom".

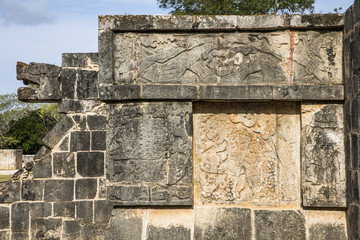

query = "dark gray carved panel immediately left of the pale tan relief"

[{"left": 107, "top": 102, "right": 192, "bottom": 205}]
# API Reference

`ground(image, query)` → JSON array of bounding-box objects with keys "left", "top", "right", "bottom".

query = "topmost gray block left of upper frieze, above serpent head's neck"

[{"left": 62, "top": 53, "right": 99, "bottom": 69}]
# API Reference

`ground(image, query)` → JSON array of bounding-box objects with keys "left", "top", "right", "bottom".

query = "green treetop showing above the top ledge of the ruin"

[{"left": 158, "top": 0, "right": 315, "bottom": 15}]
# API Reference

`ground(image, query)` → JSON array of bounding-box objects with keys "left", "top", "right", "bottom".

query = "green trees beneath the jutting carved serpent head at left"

[{"left": 0, "top": 93, "right": 62, "bottom": 154}]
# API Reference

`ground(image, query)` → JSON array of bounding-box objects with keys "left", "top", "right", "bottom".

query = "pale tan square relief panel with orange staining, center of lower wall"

[{"left": 194, "top": 103, "right": 300, "bottom": 206}]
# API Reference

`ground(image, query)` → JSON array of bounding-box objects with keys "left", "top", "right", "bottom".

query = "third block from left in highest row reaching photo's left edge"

[{"left": 44, "top": 180, "right": 74, "bottom": 202}]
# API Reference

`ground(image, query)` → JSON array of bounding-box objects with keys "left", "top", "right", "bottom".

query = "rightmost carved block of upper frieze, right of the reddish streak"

[{"left": 293, "top": 31, "right": 343, "bottom": 85}]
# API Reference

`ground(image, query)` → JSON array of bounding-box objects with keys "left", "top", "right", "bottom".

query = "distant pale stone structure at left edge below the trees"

[{"left": 0, "top": 149, "right": 22, "bottom": 170}]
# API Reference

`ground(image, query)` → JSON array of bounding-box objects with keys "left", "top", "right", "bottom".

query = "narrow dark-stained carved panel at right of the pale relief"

[{"left": 301, "top": 104, "right": 346, "bottom": 207}]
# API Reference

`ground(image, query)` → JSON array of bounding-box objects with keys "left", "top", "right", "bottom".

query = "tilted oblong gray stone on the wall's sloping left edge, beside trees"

[{"left": 43, "top": 116, "right": 74, "bottom": 148}]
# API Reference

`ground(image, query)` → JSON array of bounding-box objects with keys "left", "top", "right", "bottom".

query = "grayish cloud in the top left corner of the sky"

[{"left": 0, "top": 0, "right": 54, "bottom": 25}]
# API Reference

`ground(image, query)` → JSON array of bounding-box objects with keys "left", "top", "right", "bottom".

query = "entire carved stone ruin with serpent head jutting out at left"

[{"left": 0, "top": 1, "right": 360, "bottom": 240}]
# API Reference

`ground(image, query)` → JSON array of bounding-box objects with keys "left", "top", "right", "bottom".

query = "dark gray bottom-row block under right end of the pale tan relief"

[{"left": 255, "top": 210, "right": 305, "bottom": 240}]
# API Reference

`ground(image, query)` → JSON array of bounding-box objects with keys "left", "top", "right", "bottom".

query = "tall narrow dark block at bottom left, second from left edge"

[{"left": 11, "top": 203, "right": 29, "bottom": 232}]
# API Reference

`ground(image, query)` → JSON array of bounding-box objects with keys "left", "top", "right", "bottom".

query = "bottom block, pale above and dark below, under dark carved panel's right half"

[{"left": 146, "top": 209, "right": 192, "bottom": 240}]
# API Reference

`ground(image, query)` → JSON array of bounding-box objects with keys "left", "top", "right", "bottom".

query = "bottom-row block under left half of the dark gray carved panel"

[{"left": 105, "top": 208, "right": 145, "bottom": 240}]
